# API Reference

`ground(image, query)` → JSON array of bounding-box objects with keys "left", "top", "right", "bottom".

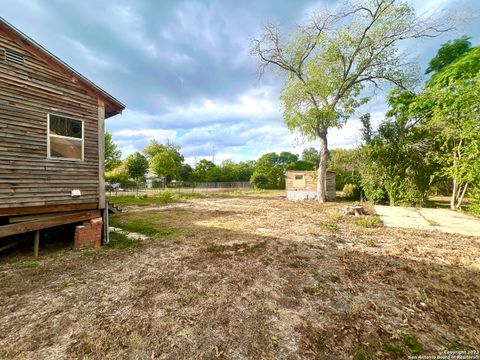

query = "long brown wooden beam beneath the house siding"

[{"left": 0, "top": 210, "right": 100, "bottom": 238}]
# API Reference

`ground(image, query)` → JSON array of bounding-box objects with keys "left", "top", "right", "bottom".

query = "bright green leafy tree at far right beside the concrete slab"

[{"left": 424, "top": 47, "right": 480, "bottom": 209}]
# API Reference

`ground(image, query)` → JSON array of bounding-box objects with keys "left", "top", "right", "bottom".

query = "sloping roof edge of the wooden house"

[{"left": 0, "top": 16, "right": 125, "bottom": 118}]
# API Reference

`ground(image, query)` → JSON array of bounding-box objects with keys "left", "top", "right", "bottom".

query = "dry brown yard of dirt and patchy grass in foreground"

[{"left": 0, "top": 193, "right": 480, "bottom": 360}]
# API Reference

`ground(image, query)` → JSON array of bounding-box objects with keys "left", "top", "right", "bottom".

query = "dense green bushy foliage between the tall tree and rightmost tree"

[{"left": 361, "top": 90, "right": 437, "bottom": 205}]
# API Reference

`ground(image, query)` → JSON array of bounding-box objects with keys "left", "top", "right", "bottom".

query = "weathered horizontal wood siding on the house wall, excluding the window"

[{"left": 0, "top": 29, "right": 99, "bottom": 216}]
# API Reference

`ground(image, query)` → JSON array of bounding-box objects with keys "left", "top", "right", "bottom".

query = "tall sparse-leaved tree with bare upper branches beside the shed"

[{"left": 252, "top": 0, "right": 446, "bottom": 202}]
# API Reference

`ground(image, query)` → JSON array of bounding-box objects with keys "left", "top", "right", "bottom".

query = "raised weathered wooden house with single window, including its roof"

[{"left": 0, "top": 17, "right": 125, "bottom": 250}]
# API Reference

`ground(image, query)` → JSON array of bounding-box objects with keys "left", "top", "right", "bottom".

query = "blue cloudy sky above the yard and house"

[{"left": 0, "top": 0, "right": 480, "bottom": 163}]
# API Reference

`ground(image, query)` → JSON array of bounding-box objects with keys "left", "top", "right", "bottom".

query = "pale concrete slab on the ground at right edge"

[{"left": 375, "top": 205, "right": 480, "bottom": 237}]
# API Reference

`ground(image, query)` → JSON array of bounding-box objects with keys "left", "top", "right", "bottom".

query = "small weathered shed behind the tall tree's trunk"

[{"left": 285, "top": 170, "right": 336, "bottom": 200}]
